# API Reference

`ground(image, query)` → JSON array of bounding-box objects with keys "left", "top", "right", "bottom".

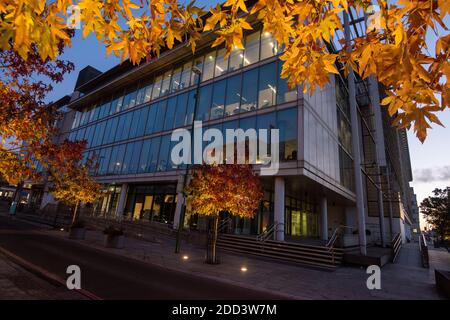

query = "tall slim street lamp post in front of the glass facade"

[{"left": 175, "top": 66, "right": 202, "bottom": 253}]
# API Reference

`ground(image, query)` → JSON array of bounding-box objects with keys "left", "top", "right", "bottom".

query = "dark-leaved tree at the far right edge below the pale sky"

[{"left": 420, "top": 187, "right": 450, "bottom": 240}]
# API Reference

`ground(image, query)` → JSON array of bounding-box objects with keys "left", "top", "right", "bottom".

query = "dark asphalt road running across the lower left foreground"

[{"left": 0, "top": 216, "right": 282, "bottom": 299}]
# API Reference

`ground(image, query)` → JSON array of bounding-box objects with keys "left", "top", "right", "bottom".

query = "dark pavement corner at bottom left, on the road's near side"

[{"left": 0, "top": 254, "right": 84, "bottom": 300}]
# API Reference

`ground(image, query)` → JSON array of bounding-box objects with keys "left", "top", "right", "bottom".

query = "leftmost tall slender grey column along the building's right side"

[{"left": 344, "top": 12, "right": 367, "bottom": 256}]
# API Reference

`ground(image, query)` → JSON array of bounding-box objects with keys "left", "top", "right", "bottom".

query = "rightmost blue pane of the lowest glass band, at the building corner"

[{"left": 277, "top": 108, "right": 298, "bottom": 160}]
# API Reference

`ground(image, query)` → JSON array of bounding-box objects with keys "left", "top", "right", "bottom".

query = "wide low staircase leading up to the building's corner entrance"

[{"left": 217, "top": 234, "right": 343, "bottom": 270}]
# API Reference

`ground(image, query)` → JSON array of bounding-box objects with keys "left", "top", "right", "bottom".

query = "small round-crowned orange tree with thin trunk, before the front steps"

[{"left": 186, "top": 164, "right": 264, "bottom": 263}]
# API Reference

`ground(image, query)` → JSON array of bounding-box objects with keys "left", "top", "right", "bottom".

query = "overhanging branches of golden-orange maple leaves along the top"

[{"left": 0, "top": 0, "right": 450, "bottom": 142}]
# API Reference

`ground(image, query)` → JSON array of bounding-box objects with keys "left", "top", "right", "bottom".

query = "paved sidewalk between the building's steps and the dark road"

[{"left": 40, "top": 225, "right": 441, "bottom": 299}]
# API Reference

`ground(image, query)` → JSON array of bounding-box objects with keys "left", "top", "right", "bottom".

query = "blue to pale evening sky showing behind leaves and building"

[{"left": 43, "top": 0, "right": 450, "bottom": 227}]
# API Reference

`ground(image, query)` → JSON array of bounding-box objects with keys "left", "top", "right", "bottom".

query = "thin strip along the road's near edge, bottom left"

[{"left": 0, "top": 246, "right": 103, "bottom": 300}]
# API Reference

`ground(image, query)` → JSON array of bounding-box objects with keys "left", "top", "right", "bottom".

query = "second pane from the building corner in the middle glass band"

[{"left": 258, "top": 62, "right": 278, "bottom": 108}]
